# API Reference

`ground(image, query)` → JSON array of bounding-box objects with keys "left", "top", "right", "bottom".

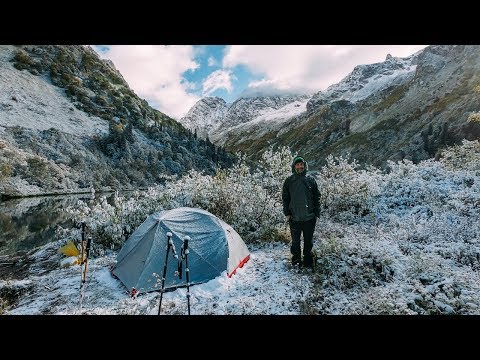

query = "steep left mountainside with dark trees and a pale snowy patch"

[{"left": 0, "top": 45, "right": 233, "bottom": 197}]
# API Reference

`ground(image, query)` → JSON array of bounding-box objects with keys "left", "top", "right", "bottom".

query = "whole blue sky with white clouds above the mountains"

[{"left": 93, "top": 45, "right": 425, "bottom": 119}]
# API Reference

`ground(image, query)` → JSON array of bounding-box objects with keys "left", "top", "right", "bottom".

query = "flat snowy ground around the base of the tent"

[{"left": 4, "top": 242, "right": 313, "bottom": 315}]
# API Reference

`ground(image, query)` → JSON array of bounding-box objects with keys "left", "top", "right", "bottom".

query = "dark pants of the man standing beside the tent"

[{"left": 290, "top": 217, "right": 317, "bottom": 266}]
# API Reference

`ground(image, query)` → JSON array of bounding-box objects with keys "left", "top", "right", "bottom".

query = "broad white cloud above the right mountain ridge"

[{"left": 222, "top": 45, "right": 425, "bottom": 92}]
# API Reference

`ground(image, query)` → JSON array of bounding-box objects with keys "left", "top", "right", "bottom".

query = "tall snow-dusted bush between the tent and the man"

[{"left": 172, "top": 148, "right": 292, "bottom": 242}]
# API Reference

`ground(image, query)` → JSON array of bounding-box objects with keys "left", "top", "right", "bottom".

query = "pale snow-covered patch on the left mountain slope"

[{"left": 0, "top": 45, "right": 108, "bottom": 136}]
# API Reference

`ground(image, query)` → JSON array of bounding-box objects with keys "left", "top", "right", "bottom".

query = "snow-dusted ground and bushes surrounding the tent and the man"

[{"left": 0, "top": 141, "right": 480, "bottom": 315}]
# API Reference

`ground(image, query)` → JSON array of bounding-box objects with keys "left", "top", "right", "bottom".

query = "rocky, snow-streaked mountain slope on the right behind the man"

[{"left": 185, "top": 45, "right": 480, "bottom": 167}]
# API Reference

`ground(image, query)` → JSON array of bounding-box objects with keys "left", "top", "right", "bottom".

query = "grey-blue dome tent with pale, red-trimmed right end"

[{"left": 112, "top": 207, "right": 250, "bottom": 293}]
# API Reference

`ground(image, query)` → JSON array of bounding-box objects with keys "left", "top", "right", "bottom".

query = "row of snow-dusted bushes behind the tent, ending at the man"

[{"left": 61, "top": 148, "right": 292, "bottom": 248}]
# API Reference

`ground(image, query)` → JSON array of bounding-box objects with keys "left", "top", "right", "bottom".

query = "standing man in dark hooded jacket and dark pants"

[{"left": 282, "top": 156, "right": 320, "bottom": 268}]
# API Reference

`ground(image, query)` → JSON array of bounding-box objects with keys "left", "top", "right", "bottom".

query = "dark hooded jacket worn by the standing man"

[{"left": 282, "top": 164, "right": 320, "bottom": 221}]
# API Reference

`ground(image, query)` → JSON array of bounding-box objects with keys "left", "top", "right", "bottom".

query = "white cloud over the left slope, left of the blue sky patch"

[{"left": 97, "top": 45, "right": 200, "bottom": 119}]
